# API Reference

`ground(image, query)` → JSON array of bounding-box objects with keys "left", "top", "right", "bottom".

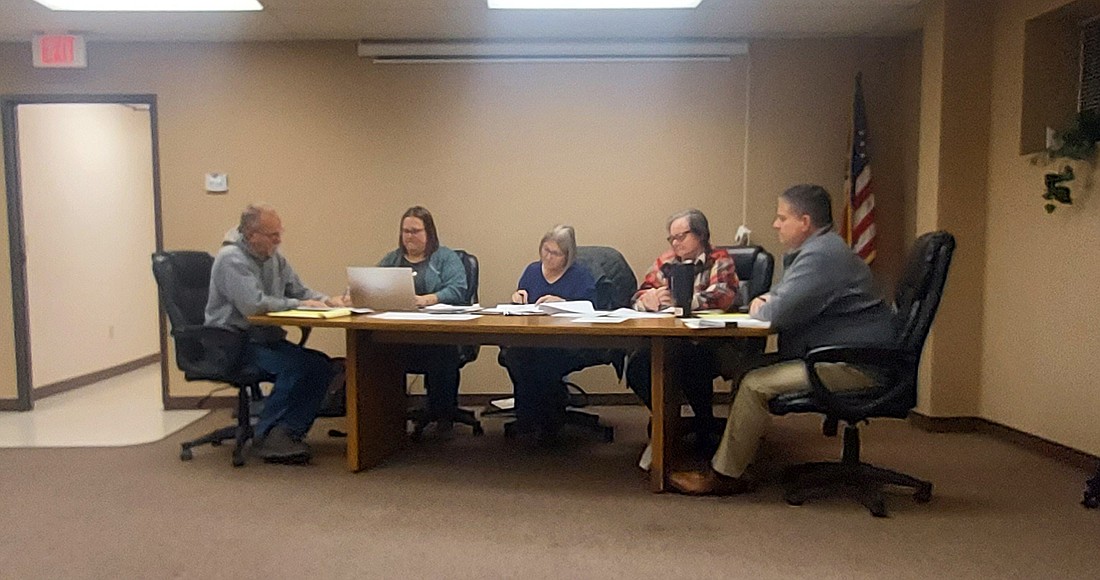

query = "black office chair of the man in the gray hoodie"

[{"left": 153, "top": 251, "right": 271, "bottom": 467}]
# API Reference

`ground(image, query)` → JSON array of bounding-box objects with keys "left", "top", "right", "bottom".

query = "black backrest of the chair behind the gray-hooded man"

[{"left": 153, "top": 251, "right": 213, "bottom": 329}]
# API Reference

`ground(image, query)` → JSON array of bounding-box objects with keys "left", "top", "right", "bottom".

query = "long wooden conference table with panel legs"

[{"left": 249, "top": 315, "right": 770, "bottom": 491}]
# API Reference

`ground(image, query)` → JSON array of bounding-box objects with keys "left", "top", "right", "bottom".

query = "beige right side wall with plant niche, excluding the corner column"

[{"left": 980, "top": 0, "right": 1100, "bottom": 455}]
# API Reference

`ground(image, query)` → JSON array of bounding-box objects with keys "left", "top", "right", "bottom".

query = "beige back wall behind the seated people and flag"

[{"left": 0, "top": 39, "right": 920, "bottom": 405}]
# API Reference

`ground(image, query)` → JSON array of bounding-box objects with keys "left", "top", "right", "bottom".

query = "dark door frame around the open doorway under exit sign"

[{"left": 0, "top": 95, "right": 168, "bottom": 411}]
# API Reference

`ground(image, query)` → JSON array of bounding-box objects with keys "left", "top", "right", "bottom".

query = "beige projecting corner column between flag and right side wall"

[{"left": 916, "top": 0, "right": 992, "bottom": 416}]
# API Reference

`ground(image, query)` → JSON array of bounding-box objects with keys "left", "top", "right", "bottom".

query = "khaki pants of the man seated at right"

[{"left": 711, "top": 361, "right": 875, "bottom": 478}]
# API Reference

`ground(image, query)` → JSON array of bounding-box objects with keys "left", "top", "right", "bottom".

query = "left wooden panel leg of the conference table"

[{"left": 347, "top": 330, "right": 405, "bottom": 471}]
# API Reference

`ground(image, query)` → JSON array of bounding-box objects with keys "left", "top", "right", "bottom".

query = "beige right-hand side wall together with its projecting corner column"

[{"left": 915, "top": 0, "right": 1100, "bottom": 453}]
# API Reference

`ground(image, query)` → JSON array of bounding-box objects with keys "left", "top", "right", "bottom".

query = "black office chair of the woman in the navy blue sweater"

[{"left": 497, "top": 245, "right": 638, "bottom": 442}]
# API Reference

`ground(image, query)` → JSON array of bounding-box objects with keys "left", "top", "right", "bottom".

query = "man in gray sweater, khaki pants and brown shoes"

[{"left": 669, "top": 185, "right": 895, "bottom": 495}]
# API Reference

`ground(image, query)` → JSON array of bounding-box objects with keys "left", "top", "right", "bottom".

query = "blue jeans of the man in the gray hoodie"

[{"left": 246, "top": 340, "right": 333, "bottom": 438}]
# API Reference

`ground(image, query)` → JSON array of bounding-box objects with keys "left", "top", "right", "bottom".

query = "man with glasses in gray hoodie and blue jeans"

[{"left": 206, "top": 205, "right": 345, "bottom": 463}]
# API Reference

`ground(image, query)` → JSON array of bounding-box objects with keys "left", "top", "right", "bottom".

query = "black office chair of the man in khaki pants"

[{"left": 769, "top": 231, "right": 955, "bottom": 517}]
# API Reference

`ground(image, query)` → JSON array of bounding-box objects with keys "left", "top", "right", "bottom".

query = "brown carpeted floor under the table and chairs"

[{"left": 0, "top": 407, "right": 1100, "bottom": 579}]
